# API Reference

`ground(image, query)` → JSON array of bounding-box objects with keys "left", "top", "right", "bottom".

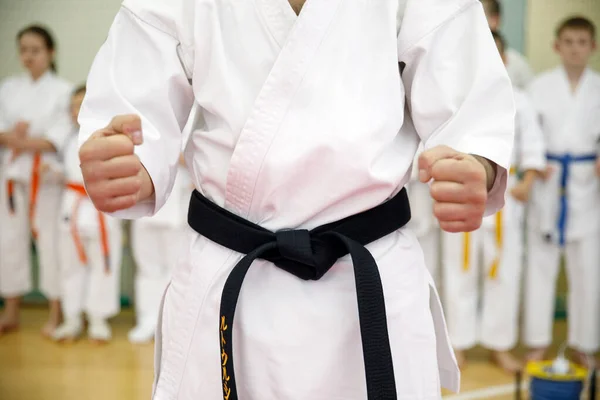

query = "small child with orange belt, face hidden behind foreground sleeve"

[{"left": 52, "top": 87, "right": 126, "bottom": 343}]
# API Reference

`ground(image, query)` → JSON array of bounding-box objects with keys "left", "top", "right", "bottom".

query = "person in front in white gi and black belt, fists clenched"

[{"left": 80, "top": 0, "right": 514, "bottom": 400}]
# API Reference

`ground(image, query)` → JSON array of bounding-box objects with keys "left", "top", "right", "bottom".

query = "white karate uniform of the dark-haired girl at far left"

[{"left": 0, "top": 72, "right": 72, "bottom": 300}]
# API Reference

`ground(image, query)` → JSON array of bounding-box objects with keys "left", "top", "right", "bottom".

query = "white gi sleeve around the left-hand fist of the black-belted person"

[{"left": 79, "top": 2, "right": 194, "bottom": 219}]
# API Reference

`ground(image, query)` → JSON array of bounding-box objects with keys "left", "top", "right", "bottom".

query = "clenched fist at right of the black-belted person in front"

[{"left": 419, "top": 146, "right": 488, "bottom": 232}]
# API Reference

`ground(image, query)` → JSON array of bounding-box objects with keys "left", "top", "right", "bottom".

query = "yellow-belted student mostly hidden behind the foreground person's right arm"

[{"left": 443, "top": 32, "right": 545, "bottom": 372}]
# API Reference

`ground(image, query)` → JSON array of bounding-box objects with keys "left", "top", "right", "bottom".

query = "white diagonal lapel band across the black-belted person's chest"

[{"left": 225, "top": 0, "right": 341, "bottom": 219}]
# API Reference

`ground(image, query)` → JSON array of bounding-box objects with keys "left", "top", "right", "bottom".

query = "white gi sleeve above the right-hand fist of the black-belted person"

[{"left": 398, "top": 0, "right": 515, "bottom": 216}]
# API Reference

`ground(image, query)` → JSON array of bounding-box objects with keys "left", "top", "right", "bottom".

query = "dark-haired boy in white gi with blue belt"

[{"left": 525, "top": 17, "right": 600, "bottom": 364}]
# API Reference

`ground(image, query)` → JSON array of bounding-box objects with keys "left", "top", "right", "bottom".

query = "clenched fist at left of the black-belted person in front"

[{"left": 79, "top": 115, "right": 154, "bottom": 212}]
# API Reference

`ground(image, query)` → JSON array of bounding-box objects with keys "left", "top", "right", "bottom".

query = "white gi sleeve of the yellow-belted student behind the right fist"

[{"left": 515, "top": 93, "right": 546, "bottom": 171}]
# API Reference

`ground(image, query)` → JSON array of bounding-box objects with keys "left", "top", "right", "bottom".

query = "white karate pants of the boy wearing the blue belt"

[{"left": 524, "top": 230, "right": 600, "bottom": 354}]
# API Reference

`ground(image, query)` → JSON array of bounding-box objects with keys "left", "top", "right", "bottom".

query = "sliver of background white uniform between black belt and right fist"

[{"left": 407, "top": 146, "right": 441, "bottom": 282}]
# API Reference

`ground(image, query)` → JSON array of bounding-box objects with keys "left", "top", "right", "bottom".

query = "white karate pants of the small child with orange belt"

[{"left": 60, "top": 217, "right": 123, "bottom": 319}]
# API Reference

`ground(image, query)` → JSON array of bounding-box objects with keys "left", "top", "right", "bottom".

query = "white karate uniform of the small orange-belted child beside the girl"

[{"left": 59, "top": 132, "right": 123, "bottom": 321}]
